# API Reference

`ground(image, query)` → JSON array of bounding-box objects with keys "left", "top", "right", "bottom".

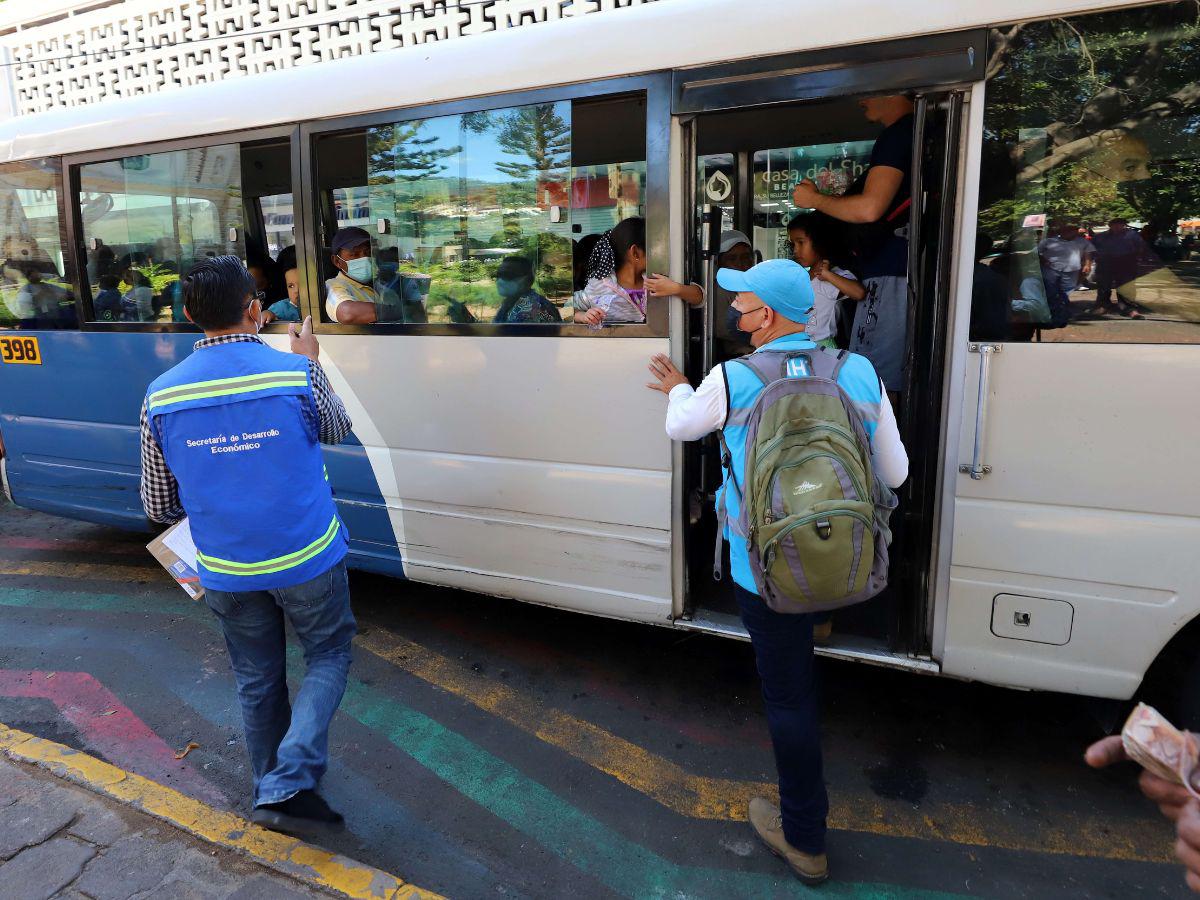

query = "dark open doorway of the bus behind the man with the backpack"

[{"left": 685, "top": 88, "right": 960, "bottom": 653}]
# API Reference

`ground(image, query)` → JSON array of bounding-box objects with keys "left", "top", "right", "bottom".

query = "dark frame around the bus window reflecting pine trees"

[{"left": 296, "top": 71, "right": 672, "bottom": 338}]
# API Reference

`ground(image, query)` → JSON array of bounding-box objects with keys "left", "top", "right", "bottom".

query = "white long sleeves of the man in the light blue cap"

[{"left": 667, "top": 366, "right": 908, "bottom": 488}]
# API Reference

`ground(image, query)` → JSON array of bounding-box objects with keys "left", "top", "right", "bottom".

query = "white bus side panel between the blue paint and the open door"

[{"left": 309, "top": 335, "right": 672, "bottom": 622}]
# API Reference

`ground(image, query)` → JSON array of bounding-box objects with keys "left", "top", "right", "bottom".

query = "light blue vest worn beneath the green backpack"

[{"left": 716, "top": 334, "right": 882, "bottom": 594}]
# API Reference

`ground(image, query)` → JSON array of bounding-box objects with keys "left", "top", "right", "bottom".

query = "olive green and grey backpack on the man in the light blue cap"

[{"left": 714, "top": 347, "right": 896, "bottom": 613}]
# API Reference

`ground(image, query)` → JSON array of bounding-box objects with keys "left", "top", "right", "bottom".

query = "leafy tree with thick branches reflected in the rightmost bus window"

[{"left": 979, "top": 0, "right": 1200, "bottom": 232}]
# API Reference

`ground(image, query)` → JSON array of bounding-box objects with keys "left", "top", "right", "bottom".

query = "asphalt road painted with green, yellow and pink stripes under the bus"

[{"left": 0, "top": 500, "right": 1187, "bottom": 898}]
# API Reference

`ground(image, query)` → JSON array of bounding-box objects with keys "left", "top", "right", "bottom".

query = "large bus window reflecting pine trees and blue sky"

[{"left": 316, "top": 91, "right": 646, "bottom": 325}]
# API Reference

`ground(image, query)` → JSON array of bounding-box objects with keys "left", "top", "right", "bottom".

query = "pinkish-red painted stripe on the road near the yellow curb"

[{"left": 0, "top": 668, "right": 229, "bottom": 809}]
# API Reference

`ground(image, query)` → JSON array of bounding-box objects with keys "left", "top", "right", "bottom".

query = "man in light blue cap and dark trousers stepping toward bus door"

[{"left": 647, "top": 259, "right": 908, "bottom": 883}]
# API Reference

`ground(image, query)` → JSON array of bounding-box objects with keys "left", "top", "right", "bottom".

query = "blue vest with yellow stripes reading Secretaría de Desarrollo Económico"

[{"left": 146, "top": 341, "right": 347, "bottom": 592}]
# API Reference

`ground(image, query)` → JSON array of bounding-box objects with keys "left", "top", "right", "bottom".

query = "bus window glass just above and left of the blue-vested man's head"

[{"left": 78, "top": 144, "right": 245, "bottom": 323}]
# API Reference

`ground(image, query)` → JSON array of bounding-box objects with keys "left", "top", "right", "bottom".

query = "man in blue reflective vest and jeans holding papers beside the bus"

[{"left": 142, "top": 256, "right": 355, "bottom": 835}]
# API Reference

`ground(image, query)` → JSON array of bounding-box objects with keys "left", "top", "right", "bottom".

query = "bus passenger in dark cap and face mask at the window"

[{"left": 325, "top": 226, "right": 427, "bottom": 325}]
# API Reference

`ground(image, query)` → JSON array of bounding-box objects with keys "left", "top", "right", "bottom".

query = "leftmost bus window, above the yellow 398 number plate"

[{"left": 0, "top": 160, "right": 77, "bottom": 330}]
